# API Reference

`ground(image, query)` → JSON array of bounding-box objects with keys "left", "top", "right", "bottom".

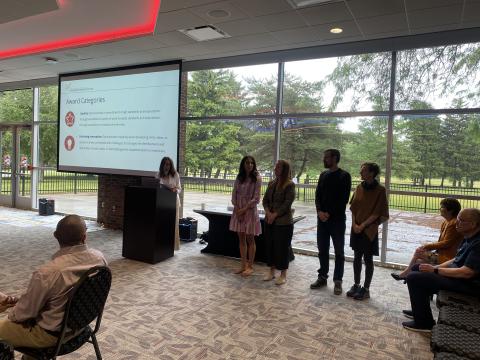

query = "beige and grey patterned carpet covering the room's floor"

[{"left": 0, "top": 215, "right": 432, "bottom": 360}]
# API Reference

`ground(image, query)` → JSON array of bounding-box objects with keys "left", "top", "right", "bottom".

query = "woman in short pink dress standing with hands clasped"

[{"left": 230, "top": 156, "right": 262, "bottom": 276}]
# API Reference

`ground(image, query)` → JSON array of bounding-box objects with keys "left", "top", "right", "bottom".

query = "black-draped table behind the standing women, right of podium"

[{"left": 193, "top": 208, "right": 305, "bottom": 262}]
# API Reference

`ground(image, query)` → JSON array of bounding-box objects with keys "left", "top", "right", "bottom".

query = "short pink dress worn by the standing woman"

[{"left": 230, "top": 176, "right": 262, "bottom": 235}]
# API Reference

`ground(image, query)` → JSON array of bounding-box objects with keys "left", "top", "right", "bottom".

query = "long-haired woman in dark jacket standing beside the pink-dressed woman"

[{"left": 263, "top": 160, "right": 295, "bottom": 285}]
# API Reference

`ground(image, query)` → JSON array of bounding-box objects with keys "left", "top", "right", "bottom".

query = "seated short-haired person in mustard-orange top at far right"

[{"left": 391, "top": 198, "right": 463, "bottom": 280}]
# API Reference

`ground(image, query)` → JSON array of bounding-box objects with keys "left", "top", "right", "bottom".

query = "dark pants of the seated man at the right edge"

[{"left": 407, "top": 264, "right": 478, "bottom": 328}]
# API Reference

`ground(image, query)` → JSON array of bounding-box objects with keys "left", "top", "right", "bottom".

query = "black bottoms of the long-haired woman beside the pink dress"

[{"left": 264, "top": 223, "right": 293, "bottom": 270}]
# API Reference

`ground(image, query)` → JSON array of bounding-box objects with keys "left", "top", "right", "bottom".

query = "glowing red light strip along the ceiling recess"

[{"left": 0, "top": 0, "right": 160, "bottom": 59}]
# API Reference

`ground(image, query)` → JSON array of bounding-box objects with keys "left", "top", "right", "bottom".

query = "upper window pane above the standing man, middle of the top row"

[{"left": 283, "top": 53, "right": 391, "bottom": 113}]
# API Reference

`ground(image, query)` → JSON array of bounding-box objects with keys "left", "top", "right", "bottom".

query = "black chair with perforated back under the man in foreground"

[{"left": 15, "top": 266, "right": 112, "bottom": 360}]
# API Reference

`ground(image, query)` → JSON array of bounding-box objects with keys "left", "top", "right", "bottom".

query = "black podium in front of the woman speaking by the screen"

[{"left": 122, "top": 185, "right": 177, "bottom": 264}]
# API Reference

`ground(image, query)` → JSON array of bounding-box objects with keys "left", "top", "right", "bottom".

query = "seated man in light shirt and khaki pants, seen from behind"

[{"left": 0, "top": 215, "right": 107, "bottom": 359}]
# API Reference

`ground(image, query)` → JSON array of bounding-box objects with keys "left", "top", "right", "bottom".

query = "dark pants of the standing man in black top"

[{"left": 317, "top": 218, "right": 345, "bottom": 281}]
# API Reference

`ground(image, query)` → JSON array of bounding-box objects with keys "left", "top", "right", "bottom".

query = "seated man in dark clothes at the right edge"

[{"left": 403, "top": 209, "right": 480, "bottom": 332}]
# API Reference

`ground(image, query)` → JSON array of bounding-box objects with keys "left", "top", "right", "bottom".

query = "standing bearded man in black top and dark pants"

[{"left": 310, "top": 149, "right": 352, "bottom": 295}]
